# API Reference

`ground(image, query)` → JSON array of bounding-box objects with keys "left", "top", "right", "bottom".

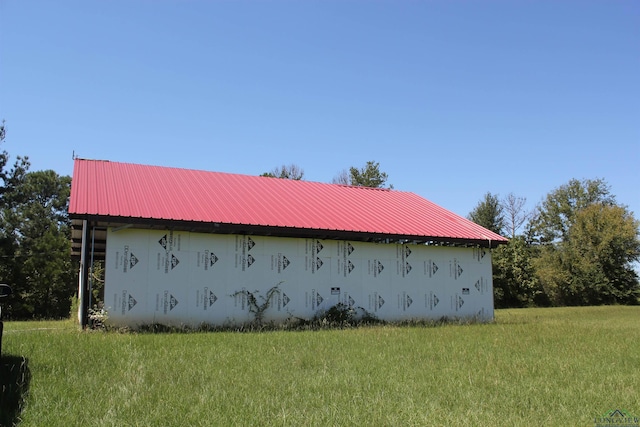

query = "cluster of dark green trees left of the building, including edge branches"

[{"left": 0, "top": 122, "right": 77, "bottom": 319}]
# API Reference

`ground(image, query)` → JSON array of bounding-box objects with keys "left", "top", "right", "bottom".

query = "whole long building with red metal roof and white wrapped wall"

[{"left": 69, "top": 159, "right": 506, "bottom": 327}]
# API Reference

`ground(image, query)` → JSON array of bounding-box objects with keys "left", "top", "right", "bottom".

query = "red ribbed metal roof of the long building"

[{"left": 69, "top": 159, "right": 506, "bottom": 245}]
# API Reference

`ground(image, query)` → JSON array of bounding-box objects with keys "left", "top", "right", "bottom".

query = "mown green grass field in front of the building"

[{"left": 0, "top": 307, "right": 640, "bottom": 427}]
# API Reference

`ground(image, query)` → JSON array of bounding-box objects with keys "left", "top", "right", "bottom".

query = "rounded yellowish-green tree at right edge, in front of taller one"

[{"left": 536, "top": 203, "right": 640, "bottom": 305}]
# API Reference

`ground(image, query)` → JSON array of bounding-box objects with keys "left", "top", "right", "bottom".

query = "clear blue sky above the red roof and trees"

[{"left": 0, "top": 0, "right": 640, "bottom": 224}]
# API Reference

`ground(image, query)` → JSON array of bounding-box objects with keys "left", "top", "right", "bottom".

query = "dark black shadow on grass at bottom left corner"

[{"left": 0, "top": 355, "right": 31, "bottom": 427}]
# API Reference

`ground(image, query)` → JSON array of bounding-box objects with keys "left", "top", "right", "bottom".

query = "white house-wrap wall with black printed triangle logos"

[{"left": 105, "top": 228, "right": 493, "bottom": 327}]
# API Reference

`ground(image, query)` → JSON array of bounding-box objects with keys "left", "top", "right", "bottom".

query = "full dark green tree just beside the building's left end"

[{"left": 3, "top": 170, "right": 75, "bottom": 319}]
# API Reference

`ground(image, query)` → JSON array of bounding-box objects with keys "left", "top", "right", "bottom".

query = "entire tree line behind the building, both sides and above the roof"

[{"left": 0, "top": 122, "right": 640, "bottom": 320}]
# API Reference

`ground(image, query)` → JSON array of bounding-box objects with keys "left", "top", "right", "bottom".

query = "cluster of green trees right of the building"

[{"left": 469, "top": 179, "right": 640, "bottom": 308}]
